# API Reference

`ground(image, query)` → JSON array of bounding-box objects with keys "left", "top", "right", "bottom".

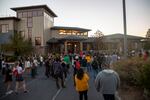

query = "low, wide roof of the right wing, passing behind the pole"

[{"left": 104, "top": 33, "right": 144, "bottom": 39}]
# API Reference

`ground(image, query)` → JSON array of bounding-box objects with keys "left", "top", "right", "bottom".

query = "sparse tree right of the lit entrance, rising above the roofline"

[{"left": 93, "top": 30, "right": 105, "bottom": 51}]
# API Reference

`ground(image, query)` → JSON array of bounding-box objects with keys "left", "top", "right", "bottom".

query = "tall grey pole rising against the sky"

[{"left": 122, "top": 0, "right": 127, "bottom": 58}]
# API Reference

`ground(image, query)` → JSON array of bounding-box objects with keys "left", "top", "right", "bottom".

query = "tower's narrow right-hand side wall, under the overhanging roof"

[{"left": 43, "top": 12, "right": 54, "bottom": 45}]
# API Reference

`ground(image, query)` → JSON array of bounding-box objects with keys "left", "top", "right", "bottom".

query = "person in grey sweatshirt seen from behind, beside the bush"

[{"left": 95, "top": 63, "right": 120, "bottom": 100}]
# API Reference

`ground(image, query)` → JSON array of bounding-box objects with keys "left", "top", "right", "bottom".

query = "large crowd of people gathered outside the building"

[{"left": 1, "top": 50, "right": 149, "bottom": 100}]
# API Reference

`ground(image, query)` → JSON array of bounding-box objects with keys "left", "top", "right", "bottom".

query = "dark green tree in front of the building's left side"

[{"left": 2, "top": 32, "right": 33, "bottom": 57}]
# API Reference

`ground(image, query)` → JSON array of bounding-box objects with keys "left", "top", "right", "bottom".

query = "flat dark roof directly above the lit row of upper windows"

[{"left": 51, "top": 26, "right": 91, "bottom": 32}]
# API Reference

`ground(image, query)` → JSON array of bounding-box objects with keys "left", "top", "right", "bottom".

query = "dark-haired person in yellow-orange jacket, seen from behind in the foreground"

[{"left": 75, "top": 68, "right": 89, "bottom": 100}]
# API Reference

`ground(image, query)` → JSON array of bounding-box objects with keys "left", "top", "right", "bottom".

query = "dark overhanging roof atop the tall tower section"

[{"left": 11, "top": 5, "right": 57, "bottom": 17}]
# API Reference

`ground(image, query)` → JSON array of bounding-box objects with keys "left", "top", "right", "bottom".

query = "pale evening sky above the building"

[{"left": 0, "top": 0, "right": 150, "bottom": 37}]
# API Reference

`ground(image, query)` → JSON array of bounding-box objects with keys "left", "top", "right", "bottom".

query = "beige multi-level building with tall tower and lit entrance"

[{"left": 0, "top": 5, "right": 145, "bottom": 54}]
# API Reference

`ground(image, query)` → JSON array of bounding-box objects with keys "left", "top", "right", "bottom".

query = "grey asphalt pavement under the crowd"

[{"left": 0, "top": 67, "right": 103, "bottom": 100}]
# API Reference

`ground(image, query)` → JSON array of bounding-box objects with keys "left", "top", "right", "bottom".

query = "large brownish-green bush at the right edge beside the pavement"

[{"left": 113, "top": 57, "right": 150, "bottom": 95}]
